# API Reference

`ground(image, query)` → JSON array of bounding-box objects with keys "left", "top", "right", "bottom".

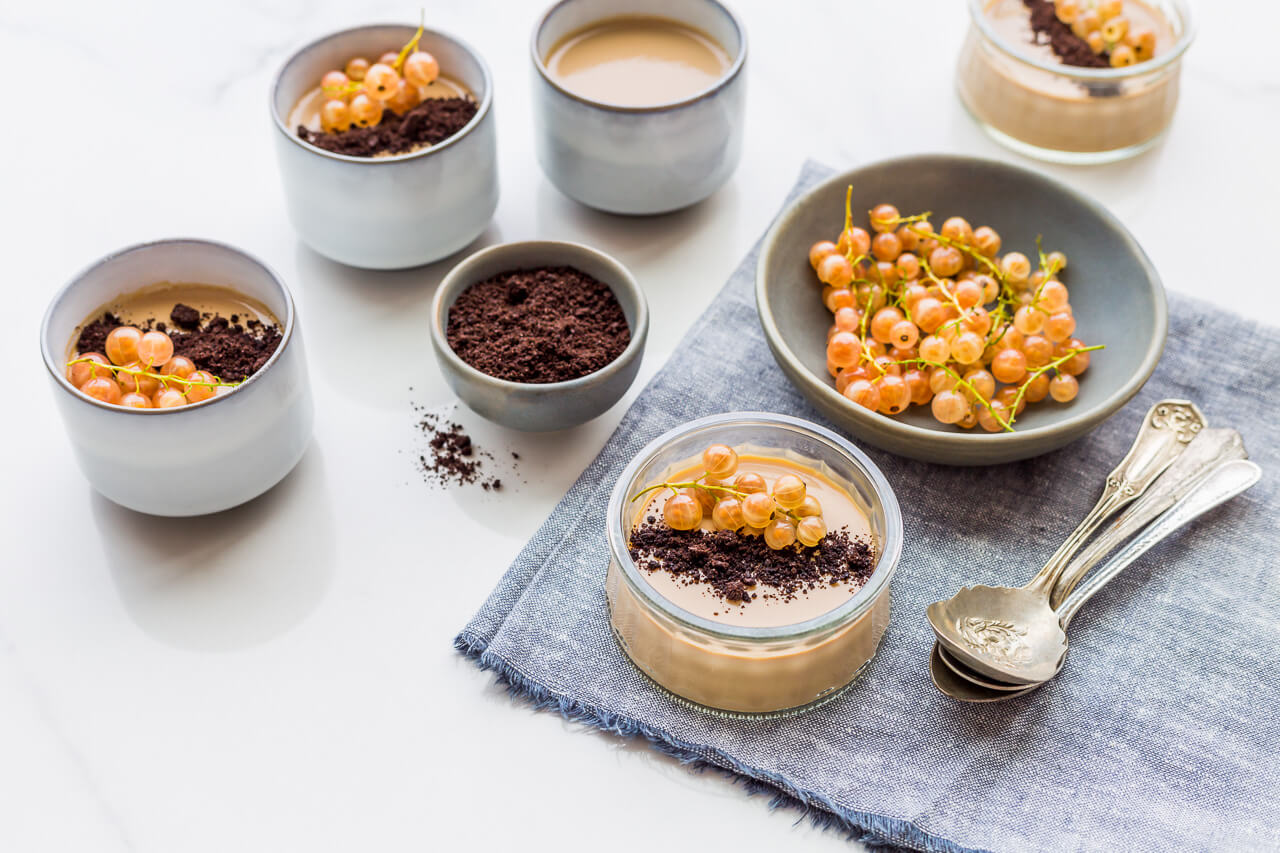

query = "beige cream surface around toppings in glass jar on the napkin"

[{"left": 637, "top": 456, "right": 874, "bottom": 628}]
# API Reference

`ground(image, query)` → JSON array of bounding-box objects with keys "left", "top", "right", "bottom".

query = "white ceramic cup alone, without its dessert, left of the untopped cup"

[{"left": 270, "top": 24, "right": 498, "bottom": 269}]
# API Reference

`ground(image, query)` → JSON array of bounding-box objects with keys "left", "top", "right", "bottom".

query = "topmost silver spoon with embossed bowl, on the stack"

[{"left": 928, "top": 400, "right": 1204, "bottom": 684}]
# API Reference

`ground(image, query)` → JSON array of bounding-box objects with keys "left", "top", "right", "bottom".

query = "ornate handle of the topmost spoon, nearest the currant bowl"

[{"left": 1025, "top": 400, "right": 1204, "bottom": 598}]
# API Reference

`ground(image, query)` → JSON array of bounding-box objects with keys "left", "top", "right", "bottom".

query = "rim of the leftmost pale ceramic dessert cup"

[{"left": 40, "top": 237, "right": 297, "bottom": 418}]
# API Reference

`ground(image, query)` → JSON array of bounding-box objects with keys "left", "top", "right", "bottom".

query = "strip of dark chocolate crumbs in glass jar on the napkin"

[{"left": 630, "top": 516, "right": 876, "bottom": 603}]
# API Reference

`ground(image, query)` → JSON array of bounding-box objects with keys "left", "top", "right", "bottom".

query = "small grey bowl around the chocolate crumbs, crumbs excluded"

[{"left": 431, "top": 241, "right": 649, "bottom": 432}]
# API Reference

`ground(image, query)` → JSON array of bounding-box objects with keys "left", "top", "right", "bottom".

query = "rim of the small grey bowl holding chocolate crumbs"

[{"left": 431, "top": 240, "right": 649, "bottom": 394}]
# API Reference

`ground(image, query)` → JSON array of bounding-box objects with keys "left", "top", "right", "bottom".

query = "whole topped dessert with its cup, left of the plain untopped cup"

[{"left": 270, "top": 24, "right": 498, "bottom": 269}]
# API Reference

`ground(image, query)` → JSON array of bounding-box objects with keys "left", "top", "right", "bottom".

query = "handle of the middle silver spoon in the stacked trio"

[{"left": 1050, "top": 429, "right": 1249, "bottom": 608}]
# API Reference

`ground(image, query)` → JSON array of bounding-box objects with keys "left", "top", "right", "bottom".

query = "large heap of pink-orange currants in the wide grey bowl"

[{"left": 809, "top": 193, "right": 1102, "bottom": 432}]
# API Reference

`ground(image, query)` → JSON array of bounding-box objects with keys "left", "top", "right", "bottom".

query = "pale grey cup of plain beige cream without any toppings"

[{"left": 531, "top": 0, "right": 746, "bottom": 215}]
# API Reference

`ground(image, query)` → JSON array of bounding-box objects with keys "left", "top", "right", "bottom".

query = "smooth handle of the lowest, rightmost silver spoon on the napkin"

[{"left": 1057, "top": 459, "right": 1262, "bottom": 630}]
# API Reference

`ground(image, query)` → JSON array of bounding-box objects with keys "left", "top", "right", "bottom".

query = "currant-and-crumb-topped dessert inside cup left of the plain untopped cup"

[{"left": 288, "top": 21, "right": 479, "bottom": 158}]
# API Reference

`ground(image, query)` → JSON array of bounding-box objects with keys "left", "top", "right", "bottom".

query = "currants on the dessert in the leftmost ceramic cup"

[{"left": 67, "top": 325, "right": 236, "bottom": 409}]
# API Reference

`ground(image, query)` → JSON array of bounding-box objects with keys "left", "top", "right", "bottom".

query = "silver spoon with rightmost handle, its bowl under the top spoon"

[{"left": 929, "top": 459, "right": 1262, "bottom": 702}]
